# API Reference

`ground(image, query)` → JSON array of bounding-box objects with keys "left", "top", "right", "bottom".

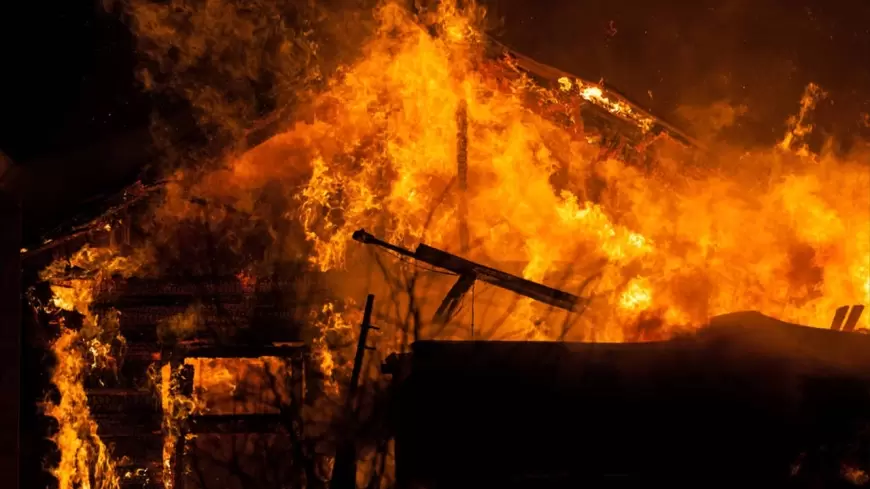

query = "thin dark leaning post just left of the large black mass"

[{"left": 329, "top": 294, "right": 375, "bottom": 489}]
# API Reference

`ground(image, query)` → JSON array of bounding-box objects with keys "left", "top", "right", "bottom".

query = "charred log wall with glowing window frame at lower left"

[{"left": 23, "top": 216, "right": 328, "bottom": 489}]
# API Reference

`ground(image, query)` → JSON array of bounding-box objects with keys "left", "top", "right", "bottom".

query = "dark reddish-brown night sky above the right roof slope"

[{"left": 495, "top": 0, "right": 870, "bottom": 144}]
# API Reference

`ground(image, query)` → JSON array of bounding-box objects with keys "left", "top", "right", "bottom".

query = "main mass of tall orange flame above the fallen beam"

[{"left": 162, "top": 2, "right": 870, "bottom": 341}]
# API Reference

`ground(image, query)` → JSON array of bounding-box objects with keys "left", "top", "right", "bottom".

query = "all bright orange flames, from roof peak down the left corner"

[{"left": 34, "top": 2, "right": 870, "bottom": 489}]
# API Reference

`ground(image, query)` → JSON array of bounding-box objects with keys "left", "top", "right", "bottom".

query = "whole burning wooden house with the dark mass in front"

[{"left": 0, "top": 4, "right": 870, "bottom": 489}]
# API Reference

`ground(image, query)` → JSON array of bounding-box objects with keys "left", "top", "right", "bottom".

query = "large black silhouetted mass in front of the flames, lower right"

[{"left": 384, "top": 313, "right": 870, "bottom": 488}]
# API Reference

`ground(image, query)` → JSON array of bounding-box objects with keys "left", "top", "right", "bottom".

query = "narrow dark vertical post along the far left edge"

[{"left": 0, "top": 193, "right": 21, "bottom": 488}]
